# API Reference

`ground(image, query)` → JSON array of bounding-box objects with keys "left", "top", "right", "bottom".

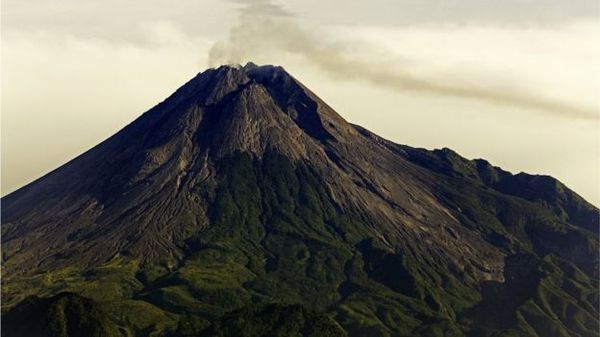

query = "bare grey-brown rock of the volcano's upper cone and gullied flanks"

[{"left": 3, "top": 66, "right": 503, "bottom": 279}]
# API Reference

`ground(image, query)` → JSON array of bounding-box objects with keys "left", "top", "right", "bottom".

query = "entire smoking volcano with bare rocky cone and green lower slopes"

[{"left": 2, "top": 63, "right": 600, "bottom": 337}]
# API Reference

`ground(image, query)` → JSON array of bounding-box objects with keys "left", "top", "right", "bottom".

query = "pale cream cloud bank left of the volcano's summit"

[{"left": 0, "top": 25, "right": 210, "bottom": 195}]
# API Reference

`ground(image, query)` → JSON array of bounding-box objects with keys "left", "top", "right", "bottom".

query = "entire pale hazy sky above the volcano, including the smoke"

[{"left": 1, "top": 0, "right": 600, "bottom": 206}]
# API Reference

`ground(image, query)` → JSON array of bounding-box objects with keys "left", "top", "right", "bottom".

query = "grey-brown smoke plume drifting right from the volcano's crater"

[{"left": 209, "top": 0, "right": 600, "bottom": 119}]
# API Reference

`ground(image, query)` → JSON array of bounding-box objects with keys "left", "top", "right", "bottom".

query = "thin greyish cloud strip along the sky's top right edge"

[{"left": 315, "top": 0, "right": 599, "bottom": 26}]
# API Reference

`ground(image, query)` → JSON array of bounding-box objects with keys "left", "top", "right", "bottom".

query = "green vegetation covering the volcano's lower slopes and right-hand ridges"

[{"left": 2, "top": 152, "right": 599, "bottom": 337}]
